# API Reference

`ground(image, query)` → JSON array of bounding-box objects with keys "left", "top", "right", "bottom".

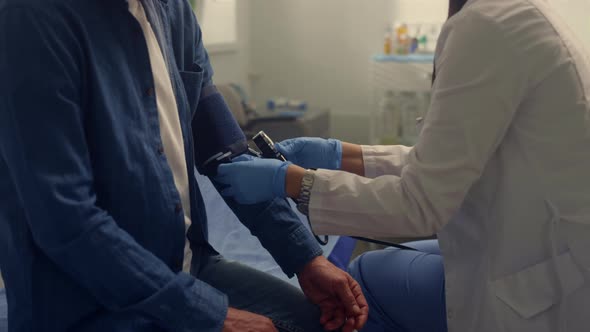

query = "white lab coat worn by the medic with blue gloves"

[{"left": 310, "top": 0, "right": 590, "bottom": 332}]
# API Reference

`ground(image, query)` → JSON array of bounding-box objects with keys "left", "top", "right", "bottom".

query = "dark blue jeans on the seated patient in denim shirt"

[{"left": 75, "top": 250, "right": 324, "bottom": 332}]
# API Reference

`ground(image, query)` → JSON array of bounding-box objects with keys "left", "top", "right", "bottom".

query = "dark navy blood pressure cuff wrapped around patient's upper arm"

[{"left": 191, "top": 86, "right": 248, "bottom": 176}]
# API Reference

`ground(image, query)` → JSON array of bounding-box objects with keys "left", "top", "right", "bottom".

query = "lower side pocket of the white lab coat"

[{"left": 493, "top": 251, "right": 585, "bottom": 319}]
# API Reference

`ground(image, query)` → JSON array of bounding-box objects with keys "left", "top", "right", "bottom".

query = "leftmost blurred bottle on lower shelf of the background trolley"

[{"left": 378, "top": 90, "right": 400, "bottom": 145}]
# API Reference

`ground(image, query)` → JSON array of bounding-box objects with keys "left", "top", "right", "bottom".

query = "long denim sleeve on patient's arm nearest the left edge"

[{"left": 0, "top": 5, "right": 228, "bottom": 332}]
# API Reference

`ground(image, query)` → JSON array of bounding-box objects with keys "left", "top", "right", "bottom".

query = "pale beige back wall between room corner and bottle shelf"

[{"left": 250, "top": 0, "right": 410, "bottom": 143}]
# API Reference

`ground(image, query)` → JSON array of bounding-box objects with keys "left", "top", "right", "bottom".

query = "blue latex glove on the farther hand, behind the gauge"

[{"left": 275, "top": 137, "right": 342, "bottom": 170}]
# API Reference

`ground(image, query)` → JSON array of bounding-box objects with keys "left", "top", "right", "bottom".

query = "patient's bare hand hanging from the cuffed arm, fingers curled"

[{"left": 297, "top": 256, "right": 369, "bottom": 332}]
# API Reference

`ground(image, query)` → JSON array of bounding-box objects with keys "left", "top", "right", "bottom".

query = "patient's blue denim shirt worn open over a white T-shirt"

[{"left": 0, "top": 0, "right": 321, "bottom": 332}]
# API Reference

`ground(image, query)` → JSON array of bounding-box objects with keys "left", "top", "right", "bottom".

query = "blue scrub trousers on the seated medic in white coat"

[{"left": 349, "top": 240, "right": 447, "bottom": 332}]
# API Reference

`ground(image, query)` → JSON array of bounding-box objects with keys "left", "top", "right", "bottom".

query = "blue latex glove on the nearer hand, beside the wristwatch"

[{"left": 214, "top": 156, "right": 290, "bottom": 204}]
